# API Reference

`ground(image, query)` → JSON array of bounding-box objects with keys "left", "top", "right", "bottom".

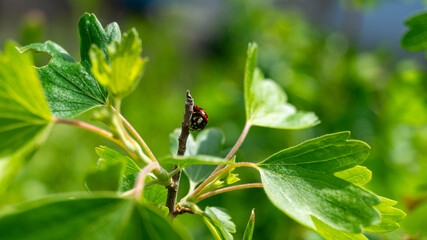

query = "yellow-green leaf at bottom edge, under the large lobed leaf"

[{"left": 311, "top": 216, "right": 368, "bottom": 240}]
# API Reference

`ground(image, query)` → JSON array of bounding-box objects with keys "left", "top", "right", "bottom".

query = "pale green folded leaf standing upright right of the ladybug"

[{"left": 244, "top": 43, "right": 319, "bottom": 129}]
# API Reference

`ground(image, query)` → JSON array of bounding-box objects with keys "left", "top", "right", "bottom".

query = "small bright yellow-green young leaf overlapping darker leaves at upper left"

[{"left": 89, "top": 28, "right": 147, "bottom": 98}]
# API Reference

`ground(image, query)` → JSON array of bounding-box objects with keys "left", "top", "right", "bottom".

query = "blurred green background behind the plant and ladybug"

[{"left": 0, "top": 0, "right": 427, "bottom": 239}]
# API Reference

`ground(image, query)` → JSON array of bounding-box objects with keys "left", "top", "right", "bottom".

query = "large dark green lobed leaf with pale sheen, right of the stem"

[{"left": 258, "top": 132, "right": 380, "bottom": 233}]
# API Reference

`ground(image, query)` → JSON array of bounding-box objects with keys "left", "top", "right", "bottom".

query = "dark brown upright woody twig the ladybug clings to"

[{"left": 166, "top": 90, "right": 194, "bottom": 216}]
